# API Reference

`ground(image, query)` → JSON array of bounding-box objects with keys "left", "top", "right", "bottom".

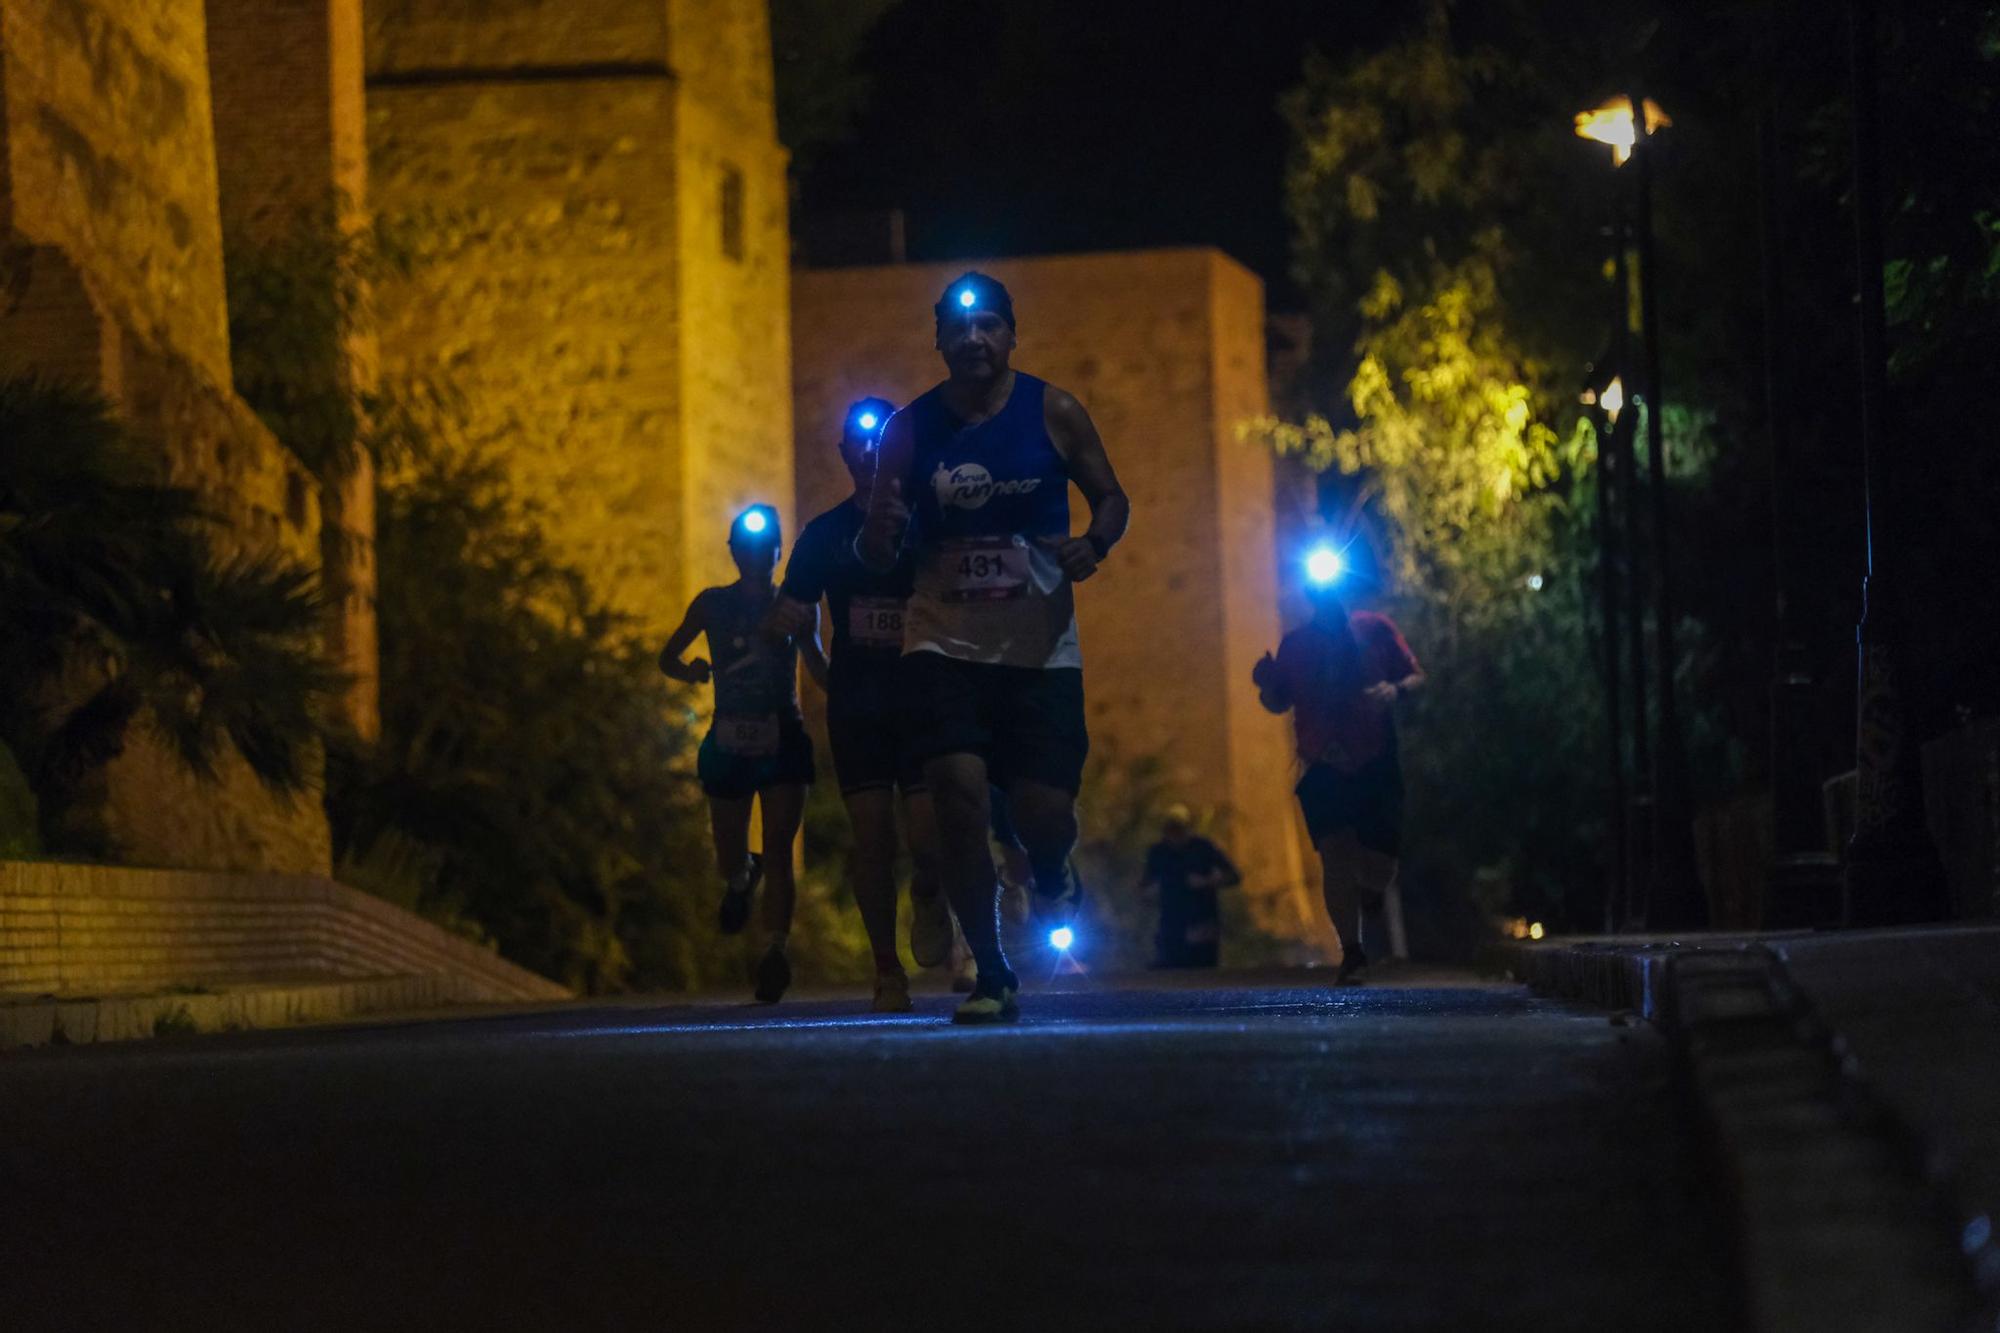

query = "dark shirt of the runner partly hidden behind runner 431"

[{"left": 778, "top": 500, "right": 914, "bottom": 689}]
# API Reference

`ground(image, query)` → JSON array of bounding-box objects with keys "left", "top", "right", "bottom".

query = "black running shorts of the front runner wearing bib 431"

[{"left": 900, "top": 652, "right": 1090, "bottom": 797}]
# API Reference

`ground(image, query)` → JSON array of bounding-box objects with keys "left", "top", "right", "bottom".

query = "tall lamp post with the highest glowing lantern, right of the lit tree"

[{"left": 1576, "top": 96, "right": 1708, "bottom": 929}]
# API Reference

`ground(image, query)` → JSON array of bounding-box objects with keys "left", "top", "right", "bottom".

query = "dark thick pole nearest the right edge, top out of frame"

[{"left": 1842, "top": 0, "right": 1948, "bottom": 925}]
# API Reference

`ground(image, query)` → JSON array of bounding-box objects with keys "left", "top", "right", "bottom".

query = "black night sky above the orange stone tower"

[{"left": 800, "top": 0, "right": 1398, "bottom": 308}]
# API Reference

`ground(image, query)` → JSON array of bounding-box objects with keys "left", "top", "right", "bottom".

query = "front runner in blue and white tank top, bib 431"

[{"left": 854, "top": 272, "right": 1130, "bottom": 1023}]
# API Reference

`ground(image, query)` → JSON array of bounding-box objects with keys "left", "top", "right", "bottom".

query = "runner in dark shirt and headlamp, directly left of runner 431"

[{"left": 770, "top": 398, "right": 952, "bottom": 1013}]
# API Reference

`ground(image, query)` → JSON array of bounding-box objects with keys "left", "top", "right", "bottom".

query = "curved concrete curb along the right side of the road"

[{"left": 1500, "top": 937, "right": 1994, "bottom": 1333}]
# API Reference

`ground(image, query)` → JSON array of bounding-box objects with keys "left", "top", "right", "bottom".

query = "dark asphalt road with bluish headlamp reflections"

[{"left": 0, "top": 973, "right": 1732, "bottom": 1333}]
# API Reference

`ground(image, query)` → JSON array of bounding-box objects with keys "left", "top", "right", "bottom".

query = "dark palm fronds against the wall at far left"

[{"left": 0, "top": 380, "right": 338, "bottom": 855}]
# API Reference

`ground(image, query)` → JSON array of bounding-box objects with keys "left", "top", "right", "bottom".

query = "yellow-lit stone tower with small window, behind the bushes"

[{"left": 366, "top": 0, "right": 796, "bottom": 636}]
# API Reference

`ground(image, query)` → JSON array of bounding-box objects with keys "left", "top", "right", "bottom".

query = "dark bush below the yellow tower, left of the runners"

[{"left": 330, "top": 440, "right": 714, "bottom": 991}]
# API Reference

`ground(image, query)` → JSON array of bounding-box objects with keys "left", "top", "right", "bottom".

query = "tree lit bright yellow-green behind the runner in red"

[{"left": 1248, "top": 6, "right": 1600, "bottom": 932}]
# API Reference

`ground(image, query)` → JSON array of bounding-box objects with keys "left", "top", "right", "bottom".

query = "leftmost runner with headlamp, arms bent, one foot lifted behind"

[{"left": 660, "top": 504, "right": 824, "bottom": 1005}]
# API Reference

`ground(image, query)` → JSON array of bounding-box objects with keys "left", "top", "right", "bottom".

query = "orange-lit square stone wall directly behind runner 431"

[{"left": 792, "top": 250, "right": 1320, "bottom": 939}]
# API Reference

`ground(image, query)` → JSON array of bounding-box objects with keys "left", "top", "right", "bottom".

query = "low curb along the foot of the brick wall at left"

[{"left": 0, "top": 975, "right": 478, "bottom": 1051}]
